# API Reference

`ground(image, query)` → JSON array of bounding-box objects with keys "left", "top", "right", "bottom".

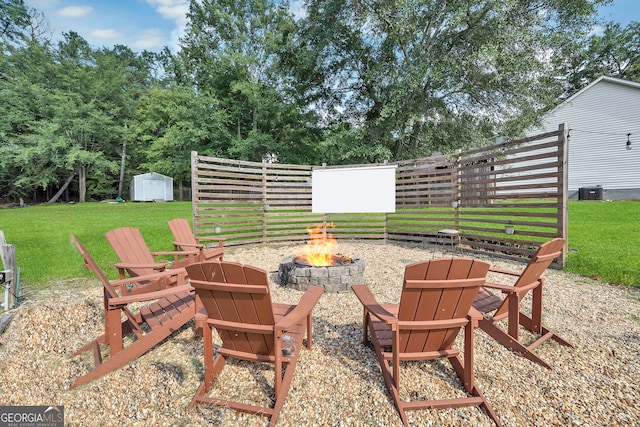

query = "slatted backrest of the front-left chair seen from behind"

[{"left": 186, "top": 261, "right": 275, "bottom": 355}]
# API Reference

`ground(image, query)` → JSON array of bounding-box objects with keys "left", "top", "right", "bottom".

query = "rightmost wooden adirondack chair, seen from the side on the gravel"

[{"left": 473, "top": 238, "right": 573, "bottom": 369}]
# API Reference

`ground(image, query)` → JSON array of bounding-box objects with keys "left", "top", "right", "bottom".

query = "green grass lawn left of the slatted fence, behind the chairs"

[{"left": 0, "top": 202, "right": 191, "bottom": 288}]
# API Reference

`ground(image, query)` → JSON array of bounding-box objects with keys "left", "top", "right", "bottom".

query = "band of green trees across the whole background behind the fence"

[{"left": 0, "top": 0, "right": 640, "bottom": 201}]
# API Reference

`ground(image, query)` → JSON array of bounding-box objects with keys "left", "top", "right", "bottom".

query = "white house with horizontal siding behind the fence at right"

[{"left": 527, "top": 77, "right": 640, "bottom": 199}]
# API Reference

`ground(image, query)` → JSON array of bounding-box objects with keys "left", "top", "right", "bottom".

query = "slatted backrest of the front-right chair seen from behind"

[{"left": 398, "top": 258, "right": 490, "bottom": 353}]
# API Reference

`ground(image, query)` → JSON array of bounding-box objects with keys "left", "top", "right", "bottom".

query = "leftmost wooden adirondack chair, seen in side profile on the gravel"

[{"left": 70, "top": 236, "right": 196, "bottom": 389}]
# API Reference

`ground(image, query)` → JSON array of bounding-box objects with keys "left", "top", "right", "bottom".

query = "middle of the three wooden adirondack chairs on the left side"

[{"left": 105, "top": 227, "right": 198, "bottom": 279}]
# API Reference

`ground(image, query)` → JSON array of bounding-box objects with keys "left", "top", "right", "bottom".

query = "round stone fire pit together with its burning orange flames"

[{"left": 278, "top": 223, "right": 365, "bottom": 292}]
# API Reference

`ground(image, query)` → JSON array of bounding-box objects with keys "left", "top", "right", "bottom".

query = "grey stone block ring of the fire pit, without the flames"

[{"left": 278, "top": 255, "right": 365, "bottom": 292}]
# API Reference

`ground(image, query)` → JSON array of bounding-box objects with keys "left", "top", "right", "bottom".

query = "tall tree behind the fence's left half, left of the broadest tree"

[{"left": 181, "top": 0, "right": 320, "bottom": 162}]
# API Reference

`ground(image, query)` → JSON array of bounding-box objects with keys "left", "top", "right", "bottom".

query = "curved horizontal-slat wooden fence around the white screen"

[{"left": 191, "top": 125, "right": 567, "bottom": 263}]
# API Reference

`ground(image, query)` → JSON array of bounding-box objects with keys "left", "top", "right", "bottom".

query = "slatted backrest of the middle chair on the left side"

[{"left": 105, "top": 227, "right": 157, "bottom": 277}]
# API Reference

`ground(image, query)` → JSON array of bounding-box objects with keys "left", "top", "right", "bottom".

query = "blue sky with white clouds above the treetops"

[{"left": 25, "top": 0, "right": 640, "bottom": 51}]
